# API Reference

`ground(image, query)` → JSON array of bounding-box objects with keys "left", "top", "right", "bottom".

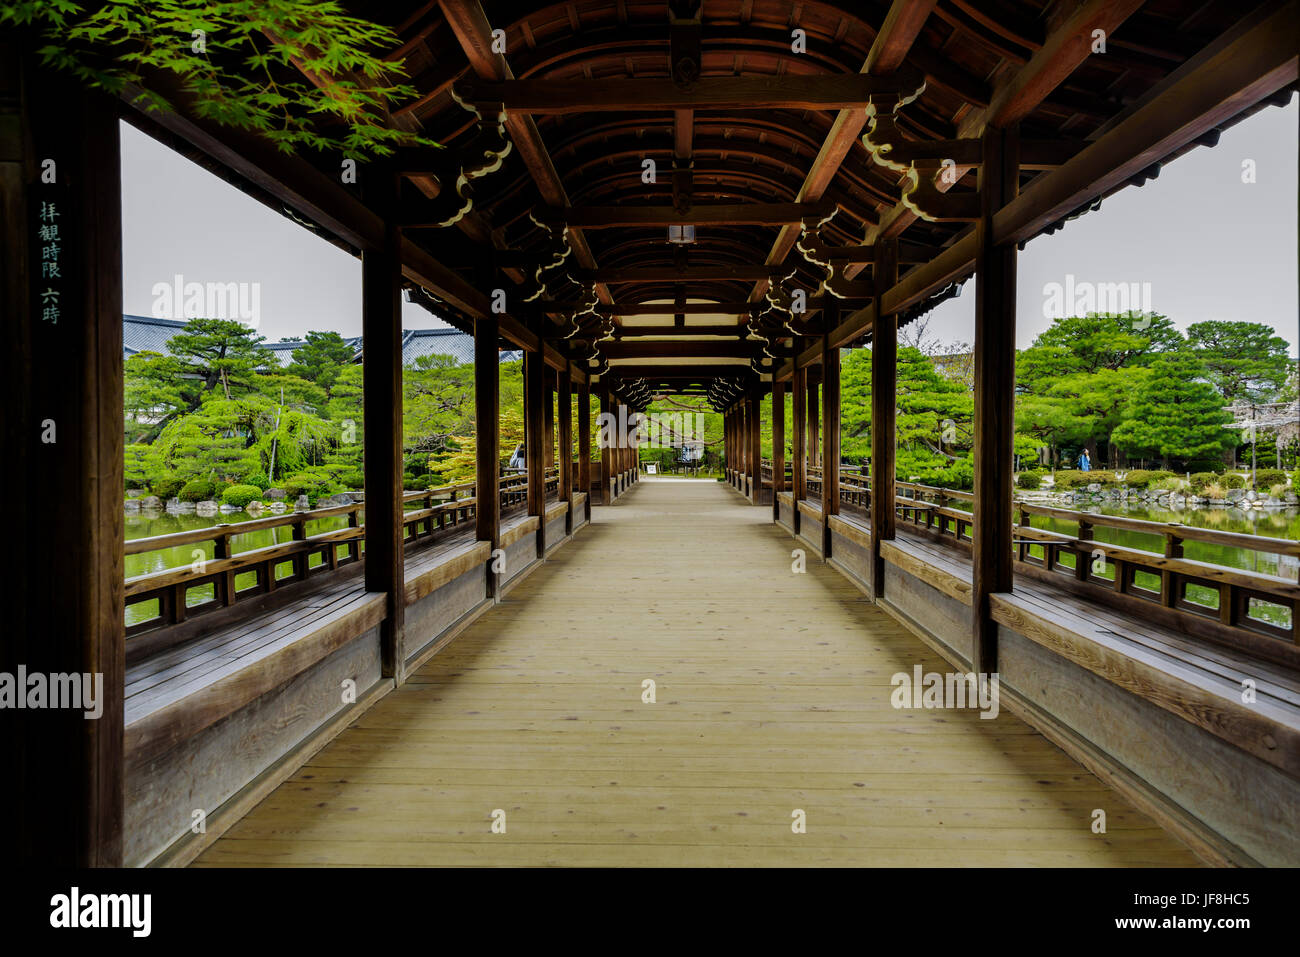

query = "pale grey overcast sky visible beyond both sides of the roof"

[{"left": 122, "top": 98, "right": 1300, "bottom": 354}]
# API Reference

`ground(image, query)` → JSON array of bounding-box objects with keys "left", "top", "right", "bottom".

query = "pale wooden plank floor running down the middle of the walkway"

[{"left": 196, "top": 480, "right": 1196, "bottom": 866}]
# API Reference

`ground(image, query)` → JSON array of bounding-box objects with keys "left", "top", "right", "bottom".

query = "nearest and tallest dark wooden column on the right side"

[{"left": 971, "top": 127, "right": 1019, "bottom": 674}]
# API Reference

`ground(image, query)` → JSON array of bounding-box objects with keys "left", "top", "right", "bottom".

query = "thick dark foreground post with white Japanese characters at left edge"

[{"left": 0, "top": 59, "right": 125, "bottom": 869}]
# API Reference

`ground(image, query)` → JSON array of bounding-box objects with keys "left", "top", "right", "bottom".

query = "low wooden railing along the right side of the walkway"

[{"left": 769, "top": 467, "right": 1300, "bottom": 649}]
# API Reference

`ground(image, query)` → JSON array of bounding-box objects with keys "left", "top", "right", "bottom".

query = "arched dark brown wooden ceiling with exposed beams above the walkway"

[{"left": 304, "top": 0, "right": 1277, "bottom": 387}]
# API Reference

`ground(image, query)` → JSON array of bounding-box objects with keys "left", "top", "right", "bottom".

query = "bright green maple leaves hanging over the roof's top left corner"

[{"left": 0, "top": 0, "right": 437, "bottom": 156}]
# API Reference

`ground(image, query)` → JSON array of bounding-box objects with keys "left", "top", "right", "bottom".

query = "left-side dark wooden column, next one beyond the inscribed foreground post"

[{"left": 361, "top": 170, "right": 406, "bottom": 683}]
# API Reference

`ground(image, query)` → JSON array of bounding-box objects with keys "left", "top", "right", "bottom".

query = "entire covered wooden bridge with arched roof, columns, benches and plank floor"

[{"left": 0, "top": 0, "right": 1300, "bottom": 865}]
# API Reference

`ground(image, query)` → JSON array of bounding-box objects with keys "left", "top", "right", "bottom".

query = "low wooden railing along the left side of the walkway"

[{"left": 124, "top": 468, "right": 559, "bottom": 647}]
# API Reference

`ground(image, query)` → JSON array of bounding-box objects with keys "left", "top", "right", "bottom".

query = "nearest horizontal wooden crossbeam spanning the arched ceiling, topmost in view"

[{"left": 456, "top": 73, "right": 915, "bottom": 114}]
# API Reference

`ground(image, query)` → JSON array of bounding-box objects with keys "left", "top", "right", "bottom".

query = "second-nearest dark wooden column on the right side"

[{"left": 871, "top": 239, "right": 898, "bottom": 598}]
